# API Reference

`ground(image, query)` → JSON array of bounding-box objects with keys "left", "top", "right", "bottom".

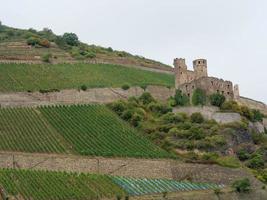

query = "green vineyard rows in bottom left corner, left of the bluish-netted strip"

[{"left": 0, "top": 169, "right": 125, "bottom": 200}]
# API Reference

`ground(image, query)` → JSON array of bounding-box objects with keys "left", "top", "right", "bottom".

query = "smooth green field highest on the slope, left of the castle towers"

[{"left": 0, "top": 64, "right": 174, "bottom": 92}]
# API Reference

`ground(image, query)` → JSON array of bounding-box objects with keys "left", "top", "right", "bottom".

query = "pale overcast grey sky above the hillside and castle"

[{"left": 0, "top": 0, "right": 267, "bottom": 103}]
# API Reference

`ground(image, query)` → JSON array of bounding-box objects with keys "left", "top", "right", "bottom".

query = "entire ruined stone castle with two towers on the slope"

[{"left": 174, "top": 58, "right": 239, "bottom": 100}]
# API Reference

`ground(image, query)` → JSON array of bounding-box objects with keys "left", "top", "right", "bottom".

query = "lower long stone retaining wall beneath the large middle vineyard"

[{"left": 0, "top": 152, "right": 254, "bottom": 184}]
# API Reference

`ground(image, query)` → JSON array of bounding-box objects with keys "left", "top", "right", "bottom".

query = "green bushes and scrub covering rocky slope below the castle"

[{"left": 109, "top": 92, "right": 267, "bottom": 173}]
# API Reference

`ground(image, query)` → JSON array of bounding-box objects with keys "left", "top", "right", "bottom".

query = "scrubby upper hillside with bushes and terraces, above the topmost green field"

[{"left": 0, "top": 24, "right": 170, "bottom": 68}]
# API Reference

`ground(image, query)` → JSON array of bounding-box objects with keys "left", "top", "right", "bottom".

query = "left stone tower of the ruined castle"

[{"left": 173, "top": 58, "right": 187, "bottom": 88}]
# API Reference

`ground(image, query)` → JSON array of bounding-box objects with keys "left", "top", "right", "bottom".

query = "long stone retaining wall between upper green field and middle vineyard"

[{"left": 0, "top": 86, "right": 175, "bottom": 107}]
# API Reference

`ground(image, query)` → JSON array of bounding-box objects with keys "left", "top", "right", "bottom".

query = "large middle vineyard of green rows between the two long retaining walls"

[{"left": 0, "top": 105, "right": 170, "bottom": 158}]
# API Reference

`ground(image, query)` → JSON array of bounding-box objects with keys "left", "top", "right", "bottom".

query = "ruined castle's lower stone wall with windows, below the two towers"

[{"left": 178, "top": 77, "right": 234, "bottom": 99}]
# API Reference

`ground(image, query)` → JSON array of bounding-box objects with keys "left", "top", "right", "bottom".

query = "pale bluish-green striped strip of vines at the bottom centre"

[{"left": 112, "top": 177, "right": 223, "bottom": 196}]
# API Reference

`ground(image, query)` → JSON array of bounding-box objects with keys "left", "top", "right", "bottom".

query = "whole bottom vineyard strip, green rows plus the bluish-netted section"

[{"left": 0, "top": 169, "right": 223, "bottom": 200}]
